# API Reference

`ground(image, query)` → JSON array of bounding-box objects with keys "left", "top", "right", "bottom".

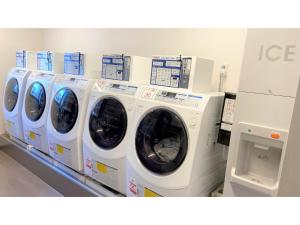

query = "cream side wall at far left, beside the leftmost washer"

[{"left": 0, "top": 29, "right": 44, "bottom": 133}]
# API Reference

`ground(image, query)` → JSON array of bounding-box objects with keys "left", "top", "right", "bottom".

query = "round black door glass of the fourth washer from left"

[{"left": 89, "top": 98, "right": 127, "bottom": 150}]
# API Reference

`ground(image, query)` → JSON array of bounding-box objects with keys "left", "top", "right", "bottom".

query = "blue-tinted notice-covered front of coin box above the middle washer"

[{"left": 64, "top": 52, "right": 84, "bottom": 75}]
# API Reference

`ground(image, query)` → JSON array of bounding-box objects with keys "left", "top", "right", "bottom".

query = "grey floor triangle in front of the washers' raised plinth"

[{"left": 0, "top": 151, "right": 62, "bottom": 197}]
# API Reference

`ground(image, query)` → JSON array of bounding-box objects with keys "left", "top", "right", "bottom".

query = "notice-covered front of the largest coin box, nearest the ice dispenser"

[{"left": 150, "top": 56, "right": 192, "bottom": 88}]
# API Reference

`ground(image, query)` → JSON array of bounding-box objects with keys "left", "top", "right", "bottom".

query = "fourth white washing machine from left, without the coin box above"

[{"left": 83, "top": 80, "right": 142, "bottom": 194}]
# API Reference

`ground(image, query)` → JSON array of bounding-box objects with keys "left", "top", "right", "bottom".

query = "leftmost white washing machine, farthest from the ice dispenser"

[{"left": 3, "top": 68, "right": 31, "bottom": 141}]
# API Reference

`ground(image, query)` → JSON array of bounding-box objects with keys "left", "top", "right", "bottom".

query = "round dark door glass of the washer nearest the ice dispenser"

[{"left": 135, "top": 109, "right": 188, "bottom": 174}]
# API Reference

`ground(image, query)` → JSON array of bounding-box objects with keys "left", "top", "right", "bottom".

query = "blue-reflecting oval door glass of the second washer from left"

[{"left": 25, "top": 82, "right": 46, "bottom": 121}]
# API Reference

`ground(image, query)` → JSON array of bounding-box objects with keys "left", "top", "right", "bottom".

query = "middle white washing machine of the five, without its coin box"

[{"left": 47, "top": 75, "right": 94, "bottom": 172}]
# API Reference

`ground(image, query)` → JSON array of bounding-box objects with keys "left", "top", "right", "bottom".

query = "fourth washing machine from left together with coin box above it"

[{"left": 83, "top": 55, "right": 150, "bottom": 194}]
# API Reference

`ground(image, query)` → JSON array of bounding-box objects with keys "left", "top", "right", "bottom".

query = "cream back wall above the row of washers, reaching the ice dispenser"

[{"left": 44, "top": 29, "right": 247, "bottom": 92}]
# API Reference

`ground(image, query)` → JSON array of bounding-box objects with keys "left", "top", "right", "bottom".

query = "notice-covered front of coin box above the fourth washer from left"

[{"left": 101, "top": 55, "right": 131, "bottom": 81}]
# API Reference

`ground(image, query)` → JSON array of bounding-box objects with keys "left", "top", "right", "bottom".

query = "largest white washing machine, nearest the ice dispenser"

[{"left": 126, "top": 86, "right": 225, "bottom": 197}]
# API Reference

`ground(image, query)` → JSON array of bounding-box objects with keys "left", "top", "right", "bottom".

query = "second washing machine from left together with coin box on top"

[{"left": 22, "top": 51, "right": 63, "bottom": 154}]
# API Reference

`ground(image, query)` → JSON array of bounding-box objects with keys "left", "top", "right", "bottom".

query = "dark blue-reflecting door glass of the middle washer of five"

[{"left": 51, "top": 88, "right": 78, "bottom": 134}]
